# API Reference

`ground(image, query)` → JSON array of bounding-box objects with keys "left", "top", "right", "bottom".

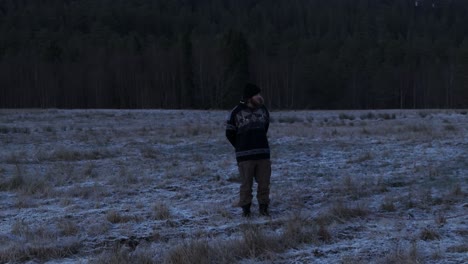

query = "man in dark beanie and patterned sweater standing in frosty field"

[{"left": 226, "top": 83, "right": 271, "bottom": 217}]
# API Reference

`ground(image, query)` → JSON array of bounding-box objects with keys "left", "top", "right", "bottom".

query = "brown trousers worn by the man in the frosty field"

[{"left": 238, "top": 159, "right": 271, "bottom": 206}]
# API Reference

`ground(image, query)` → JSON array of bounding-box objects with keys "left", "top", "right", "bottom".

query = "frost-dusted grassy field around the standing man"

[{"left": 0, "top": 109, "right": 468, "bottom": 263}]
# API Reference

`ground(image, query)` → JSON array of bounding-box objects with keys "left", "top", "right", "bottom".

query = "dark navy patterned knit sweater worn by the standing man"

[{"left": 226, "top": 102, "right": 270, "bottom": 162}]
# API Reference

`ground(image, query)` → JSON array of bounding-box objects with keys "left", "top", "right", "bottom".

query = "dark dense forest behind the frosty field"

[{"left": 0, "top": 0, "right": 468, "bottom": 109}]
